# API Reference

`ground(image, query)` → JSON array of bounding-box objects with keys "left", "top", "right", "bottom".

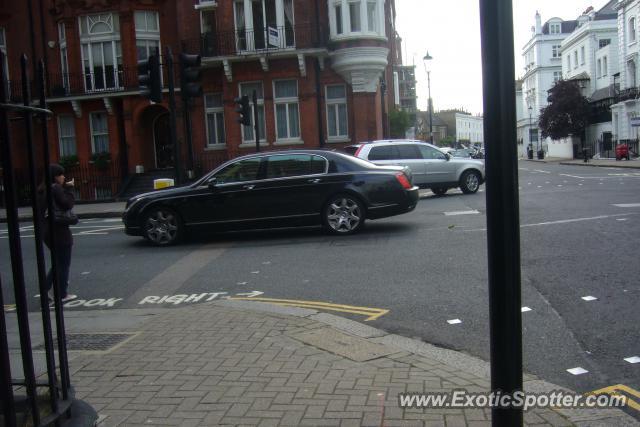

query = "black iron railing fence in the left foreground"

[{"left": 0, "top": 51, "right": 97, "bottom": 427}]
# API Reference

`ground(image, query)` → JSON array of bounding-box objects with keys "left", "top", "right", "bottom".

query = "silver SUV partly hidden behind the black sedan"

[{"left": 345, "top": 140, "right": 484, "bottom": 195}]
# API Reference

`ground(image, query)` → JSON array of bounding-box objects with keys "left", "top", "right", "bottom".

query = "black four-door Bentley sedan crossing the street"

[{"left": 123, "top": 150, "right": 418, "bottom": 245}]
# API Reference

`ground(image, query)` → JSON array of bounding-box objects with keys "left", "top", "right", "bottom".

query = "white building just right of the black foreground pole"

[{"left": 517, "top": 12, "right": 578, "bottom": 156}]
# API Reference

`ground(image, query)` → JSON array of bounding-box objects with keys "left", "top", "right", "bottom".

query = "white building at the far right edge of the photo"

[{"left": 611, "top": 0, "right": 640, "bottom": 143}]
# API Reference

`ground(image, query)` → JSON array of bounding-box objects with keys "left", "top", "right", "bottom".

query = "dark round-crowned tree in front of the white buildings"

[{"left": 539, "top": 80, "right": 589, "bottom": 145}]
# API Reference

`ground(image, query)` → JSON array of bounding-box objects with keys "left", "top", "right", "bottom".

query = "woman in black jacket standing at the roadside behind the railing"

[{"left": 38, "top": 164, "right": 77, "bottom": 302}]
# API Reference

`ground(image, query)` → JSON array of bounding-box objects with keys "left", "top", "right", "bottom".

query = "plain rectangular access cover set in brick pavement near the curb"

[{"left": 292, "top": 328, "right": 398, "bottom": 362}]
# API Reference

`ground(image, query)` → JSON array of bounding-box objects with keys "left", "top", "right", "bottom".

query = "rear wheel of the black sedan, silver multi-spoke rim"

[{"left": 322, "top": 194, "right": 365, "bottom": 236}]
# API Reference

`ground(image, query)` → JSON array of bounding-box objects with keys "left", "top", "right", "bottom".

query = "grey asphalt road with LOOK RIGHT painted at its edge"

[{"left": 0, "top": 162, "right": 640, "bottom": 402}]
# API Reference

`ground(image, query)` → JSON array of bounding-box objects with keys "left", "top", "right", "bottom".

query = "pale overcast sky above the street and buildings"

[{"left": 396, "top": 0, "right": 607, "bottom": 114}]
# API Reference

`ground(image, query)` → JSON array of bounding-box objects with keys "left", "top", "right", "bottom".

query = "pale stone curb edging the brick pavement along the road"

[{"left": 209, "top": 300, "right": 638, "bottom": 427}]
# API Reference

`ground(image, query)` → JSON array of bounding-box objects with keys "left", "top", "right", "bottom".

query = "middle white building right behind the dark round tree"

[{"left": 564, "top": 0, "right": 618, "bottom": 158}]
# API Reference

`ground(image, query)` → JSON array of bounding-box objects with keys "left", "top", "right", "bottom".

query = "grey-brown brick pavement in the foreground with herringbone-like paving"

[{"left": 61, "top": 301, "right": 634, "bottom": 427}]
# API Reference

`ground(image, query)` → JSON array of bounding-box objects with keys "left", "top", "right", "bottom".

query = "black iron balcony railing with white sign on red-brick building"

[{"left": 182, "top": 24, "right": 326, "bottom": 57}]
